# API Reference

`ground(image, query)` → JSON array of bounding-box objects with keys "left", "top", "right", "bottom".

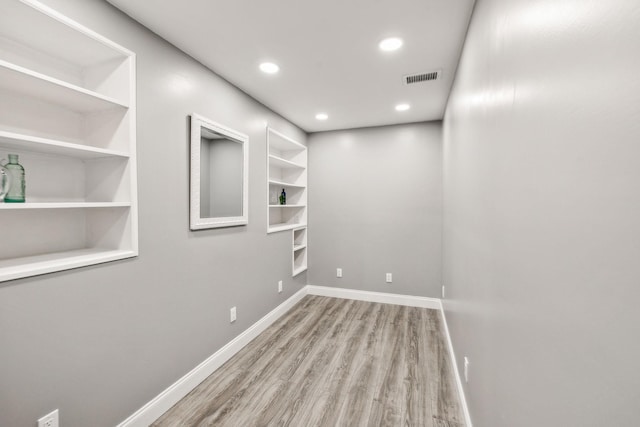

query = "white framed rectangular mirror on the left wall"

[{"left": 190, "top": 114, "right": 249, "bottom": 230}]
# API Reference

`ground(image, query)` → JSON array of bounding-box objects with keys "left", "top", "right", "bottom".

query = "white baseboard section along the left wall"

[{"left": 118, "top": 287, "right": 307, "bottom": 427}]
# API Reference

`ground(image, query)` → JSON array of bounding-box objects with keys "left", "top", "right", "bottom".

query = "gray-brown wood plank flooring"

[{"left": 152, "top": 296, "right": 464, "bottom": 427}]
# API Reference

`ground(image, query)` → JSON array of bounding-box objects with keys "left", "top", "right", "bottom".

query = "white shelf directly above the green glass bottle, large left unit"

[{"left": 0, "top": 130, "right": 129, "bottom": 160}]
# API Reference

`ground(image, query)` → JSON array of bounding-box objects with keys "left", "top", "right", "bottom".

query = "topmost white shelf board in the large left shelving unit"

[{"left": 0, "top": 59, "right": 127, "bottom": 113}]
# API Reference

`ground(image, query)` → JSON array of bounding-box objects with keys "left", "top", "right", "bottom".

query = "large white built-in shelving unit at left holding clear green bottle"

[{"left": 0, "top": 0, "right": 138, "bottom": 281}]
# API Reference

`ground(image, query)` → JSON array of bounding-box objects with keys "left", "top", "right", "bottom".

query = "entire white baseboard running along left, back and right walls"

[{"left": 117, "top": 285, "right": 472, "bottom": 427}]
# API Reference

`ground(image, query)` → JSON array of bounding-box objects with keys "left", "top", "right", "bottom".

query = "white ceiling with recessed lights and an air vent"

[{"left": 108, "top": 0, "right": 474, "bottom": 132}]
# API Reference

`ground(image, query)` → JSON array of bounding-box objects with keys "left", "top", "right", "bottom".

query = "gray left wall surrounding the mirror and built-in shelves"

[{"left": 0, "top": 0, "right": 306, "bottom": 427}]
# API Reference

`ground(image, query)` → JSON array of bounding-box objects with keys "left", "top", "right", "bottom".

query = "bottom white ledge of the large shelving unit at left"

[{"left": 0, "top": 248, "right": 137, "bottom": 282}]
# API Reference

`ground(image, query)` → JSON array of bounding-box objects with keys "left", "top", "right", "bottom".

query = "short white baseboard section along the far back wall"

[{"left": 307, "top": 285, "right": 442, "bottom": 310}]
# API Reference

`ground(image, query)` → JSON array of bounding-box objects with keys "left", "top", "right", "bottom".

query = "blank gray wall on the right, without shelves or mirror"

[{"left": 443, "top": 0, "right": 640, "bottom": 427}]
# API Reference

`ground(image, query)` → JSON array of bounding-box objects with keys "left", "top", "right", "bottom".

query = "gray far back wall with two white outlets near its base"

[{"left": 308, "top": 122, "right": 442, "bottom": 297}]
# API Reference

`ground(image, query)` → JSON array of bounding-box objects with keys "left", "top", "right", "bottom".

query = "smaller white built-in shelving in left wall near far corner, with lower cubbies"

[{"left": 267, "top": 127, "right": 307, "bottom": 276}]
